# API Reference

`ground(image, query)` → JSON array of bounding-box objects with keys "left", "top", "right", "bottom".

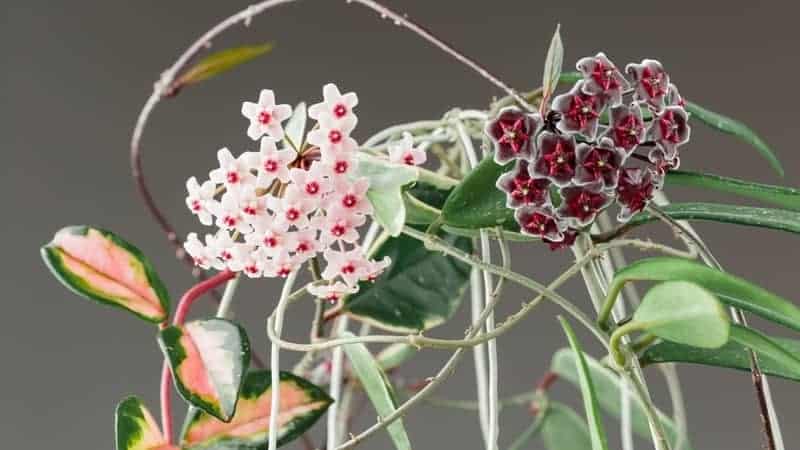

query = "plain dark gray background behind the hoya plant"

[{"left": 0, "top": 0, "right": 800, "bottom": 450}]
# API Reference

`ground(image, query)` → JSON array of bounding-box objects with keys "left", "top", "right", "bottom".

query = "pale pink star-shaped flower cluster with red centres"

[{"left": 185, "top": 84, "right": 390, "bottom": 300}]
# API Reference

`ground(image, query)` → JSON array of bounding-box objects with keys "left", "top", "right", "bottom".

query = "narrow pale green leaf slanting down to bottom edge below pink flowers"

[{"left": 343, "top": 332, "right": 411, "bottom": 450}]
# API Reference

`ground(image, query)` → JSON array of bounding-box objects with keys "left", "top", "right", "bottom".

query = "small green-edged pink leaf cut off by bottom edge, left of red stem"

[{"left": 114, "top": 397, "right": 178, "bottom": 450}]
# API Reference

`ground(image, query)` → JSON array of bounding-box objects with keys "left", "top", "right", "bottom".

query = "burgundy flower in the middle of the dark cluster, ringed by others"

[{"left": 575, "top": 138, "right": 627, "bottom": 190}]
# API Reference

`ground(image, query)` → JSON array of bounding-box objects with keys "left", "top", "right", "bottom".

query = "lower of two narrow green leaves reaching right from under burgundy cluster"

[{"left": 628, "top": 203, "right": 800, "bottom": 233}]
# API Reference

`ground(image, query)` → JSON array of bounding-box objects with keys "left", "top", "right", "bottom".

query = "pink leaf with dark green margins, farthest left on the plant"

[{"left": 41, "top": 226, "right": 169, "bottom": 323}]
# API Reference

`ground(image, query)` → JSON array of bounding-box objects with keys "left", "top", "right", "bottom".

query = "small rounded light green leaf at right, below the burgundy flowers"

[{"left": 631, "top": 281, "right": 730, "bottom": 348}]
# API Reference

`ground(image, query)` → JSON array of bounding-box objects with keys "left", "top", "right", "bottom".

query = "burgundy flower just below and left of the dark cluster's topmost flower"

[{"left": 553, "top": 81, "right": 606, "bottom": 139}]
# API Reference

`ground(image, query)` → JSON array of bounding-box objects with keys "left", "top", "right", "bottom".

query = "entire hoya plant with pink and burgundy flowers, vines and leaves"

[{"left": 41, "top": 0, "right": 800, "bottom": 450}]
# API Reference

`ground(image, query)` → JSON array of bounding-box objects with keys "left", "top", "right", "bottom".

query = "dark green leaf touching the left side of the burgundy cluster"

[{"left": 442, "top": 158, "right": 514, "bottom": 229}]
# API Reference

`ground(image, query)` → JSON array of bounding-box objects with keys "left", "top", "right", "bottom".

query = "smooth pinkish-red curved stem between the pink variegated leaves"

[{"left": 161, "top": 270, "right": 236, "bottom": 445}]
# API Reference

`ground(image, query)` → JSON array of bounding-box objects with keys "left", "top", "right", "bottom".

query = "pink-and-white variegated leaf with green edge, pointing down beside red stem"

[{"left": 158, "top": 319, "right": 250, "bottom": 422}]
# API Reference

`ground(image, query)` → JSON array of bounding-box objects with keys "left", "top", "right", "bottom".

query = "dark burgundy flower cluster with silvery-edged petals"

[{"left": 485, "top": 53, "right": 690, "bottom": 249}]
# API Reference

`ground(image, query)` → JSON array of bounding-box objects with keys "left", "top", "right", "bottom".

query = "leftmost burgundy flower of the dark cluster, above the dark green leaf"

[{"left": 485, "top": 106, "right": 543, "bottom": 164}]
